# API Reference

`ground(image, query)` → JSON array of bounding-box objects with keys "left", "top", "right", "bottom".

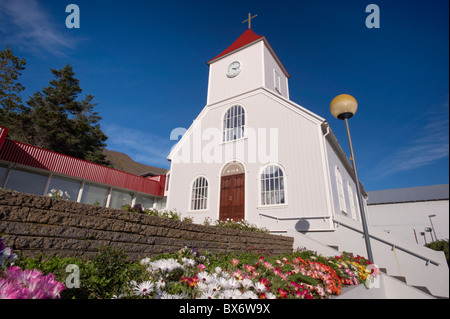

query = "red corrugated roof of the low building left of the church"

[{"left": 0, "top": 139, "right": 166, "bottom": 196}]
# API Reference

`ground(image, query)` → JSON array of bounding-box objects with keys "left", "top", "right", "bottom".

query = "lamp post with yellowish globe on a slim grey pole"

[{"left": 330, "top": 94, "right": 374, "bottom": 263}]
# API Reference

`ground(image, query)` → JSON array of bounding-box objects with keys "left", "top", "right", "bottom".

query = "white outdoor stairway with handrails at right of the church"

[{"left": 284, "top": 226, "right": 449, "bottom": 299}]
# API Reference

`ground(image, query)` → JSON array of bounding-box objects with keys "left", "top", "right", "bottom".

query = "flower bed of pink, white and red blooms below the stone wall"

[{"left": 0, "top": 238, "right": 376, "bottom": 299}]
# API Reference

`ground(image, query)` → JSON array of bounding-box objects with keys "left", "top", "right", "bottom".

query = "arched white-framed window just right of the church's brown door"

[{"left": 261, "top": 165, "right": 286, "bottom": 206}]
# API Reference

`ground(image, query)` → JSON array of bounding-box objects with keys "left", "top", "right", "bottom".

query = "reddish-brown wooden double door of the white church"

[{"left": 219, "top": 173, "right": 245, "bottom": 221}]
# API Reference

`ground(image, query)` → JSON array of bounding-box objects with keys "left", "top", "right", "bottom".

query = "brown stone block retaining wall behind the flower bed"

[{"left": 0, "top": 190, "right": 294, "bottom": 260}]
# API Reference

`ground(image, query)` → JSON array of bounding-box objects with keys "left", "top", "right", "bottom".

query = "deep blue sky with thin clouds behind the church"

[{"left": 0, "top": 0, "right": 449, "bottom": 191}]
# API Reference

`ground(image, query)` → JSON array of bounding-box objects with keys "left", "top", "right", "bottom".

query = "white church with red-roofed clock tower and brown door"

[{"left": 167, "top": 29, "right": 359, "bottom": 231}]
